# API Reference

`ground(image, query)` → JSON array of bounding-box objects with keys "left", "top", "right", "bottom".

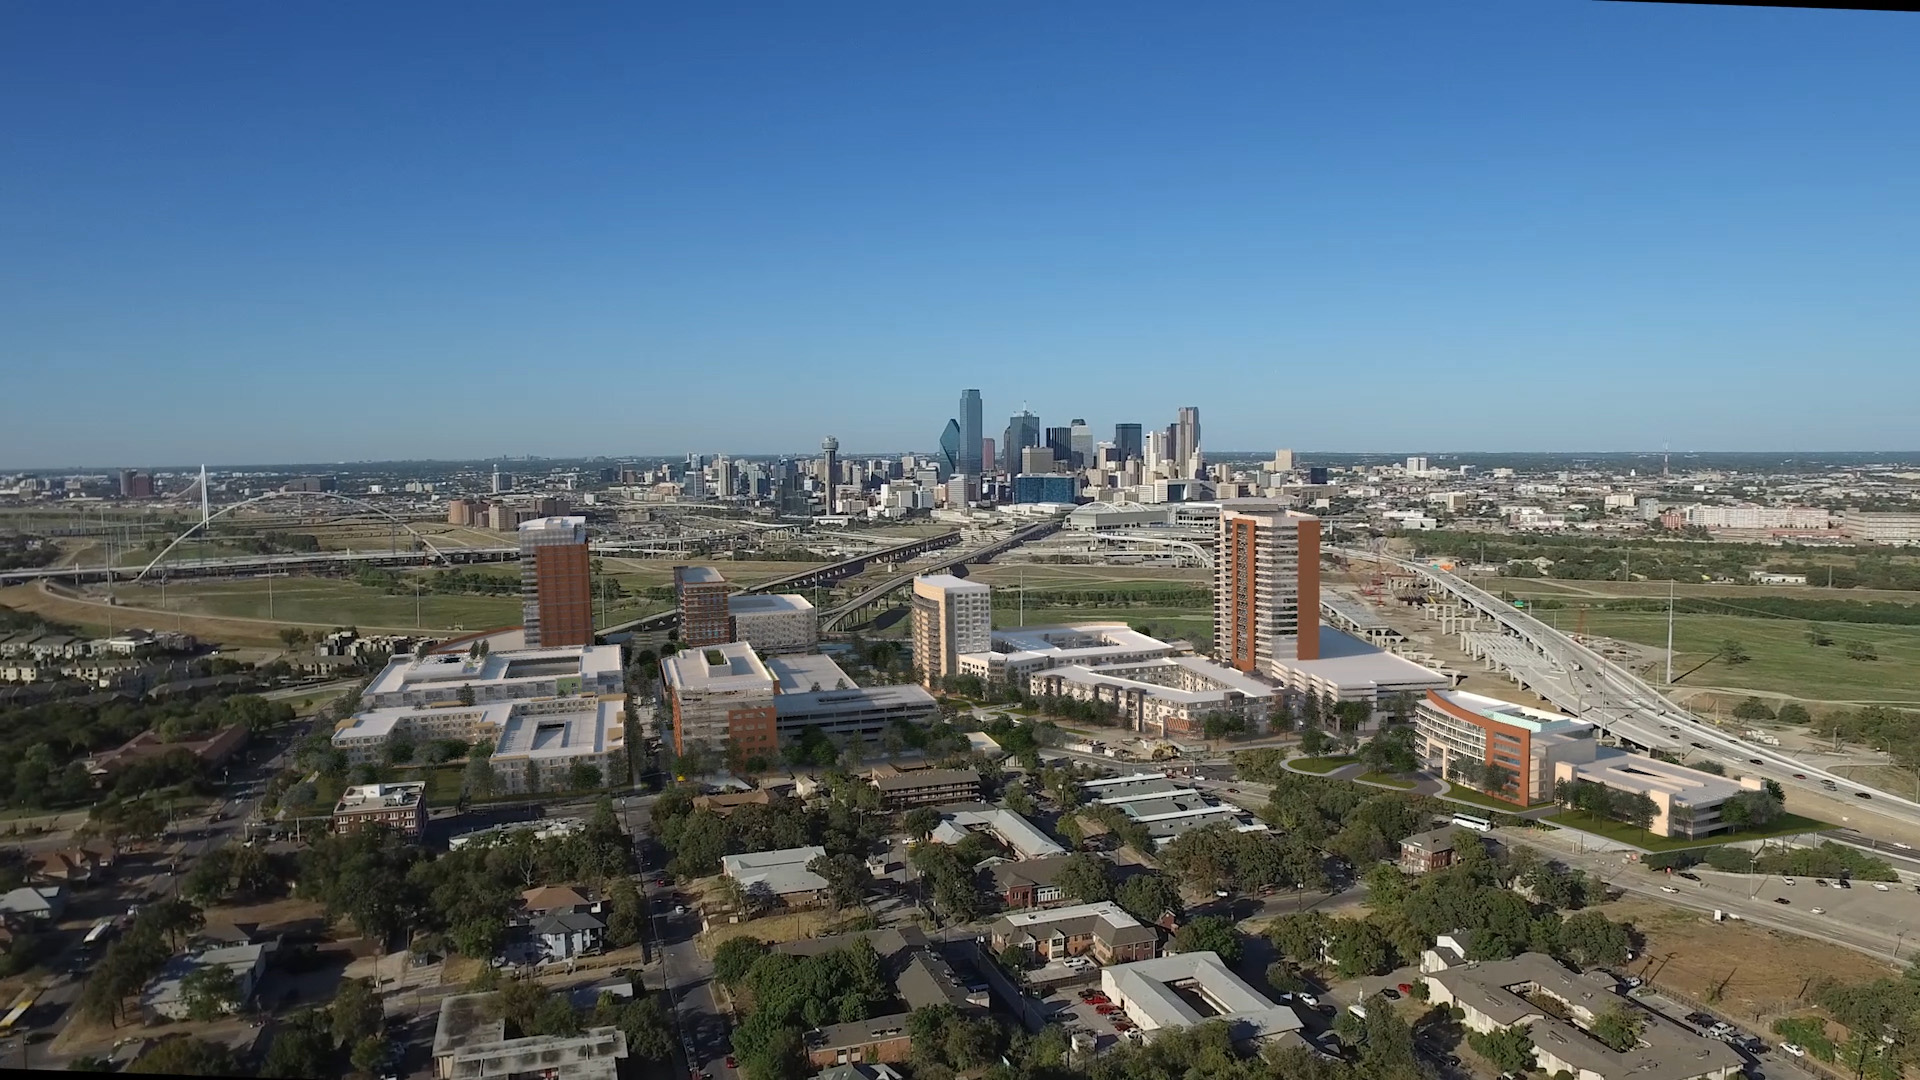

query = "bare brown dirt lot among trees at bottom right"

[{"left": 1601, "top": 897, "right": 1897, "bottom": 1020}]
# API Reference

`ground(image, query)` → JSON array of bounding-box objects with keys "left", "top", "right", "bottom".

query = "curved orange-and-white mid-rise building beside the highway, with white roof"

[{"left": 1413, "top": 690, "right": 1596, "bottom": 805}]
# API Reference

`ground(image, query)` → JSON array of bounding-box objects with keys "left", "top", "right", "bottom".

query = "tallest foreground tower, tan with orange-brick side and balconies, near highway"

[{"left": 1213, "top": 500, "right": 1319, "bottom": 673}]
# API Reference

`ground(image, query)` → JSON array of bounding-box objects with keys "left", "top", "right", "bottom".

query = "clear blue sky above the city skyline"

[{"left": 0, "top": 0, "right": 1920, "bottom": 467}]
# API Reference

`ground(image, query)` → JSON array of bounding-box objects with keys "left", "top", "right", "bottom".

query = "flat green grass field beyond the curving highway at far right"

[{"left": 1557, "top": 611, "right": 1920, "bottom": 703}]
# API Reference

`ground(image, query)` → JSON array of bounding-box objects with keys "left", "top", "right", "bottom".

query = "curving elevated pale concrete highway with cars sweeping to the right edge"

[{"left": 1332, "top": 548, "right": 1920, "bottom": 822}]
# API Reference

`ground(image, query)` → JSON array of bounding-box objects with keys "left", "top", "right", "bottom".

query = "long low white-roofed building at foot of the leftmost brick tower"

[{"left": 361, "top": 646, "right": 626, "bottom": 709}]
